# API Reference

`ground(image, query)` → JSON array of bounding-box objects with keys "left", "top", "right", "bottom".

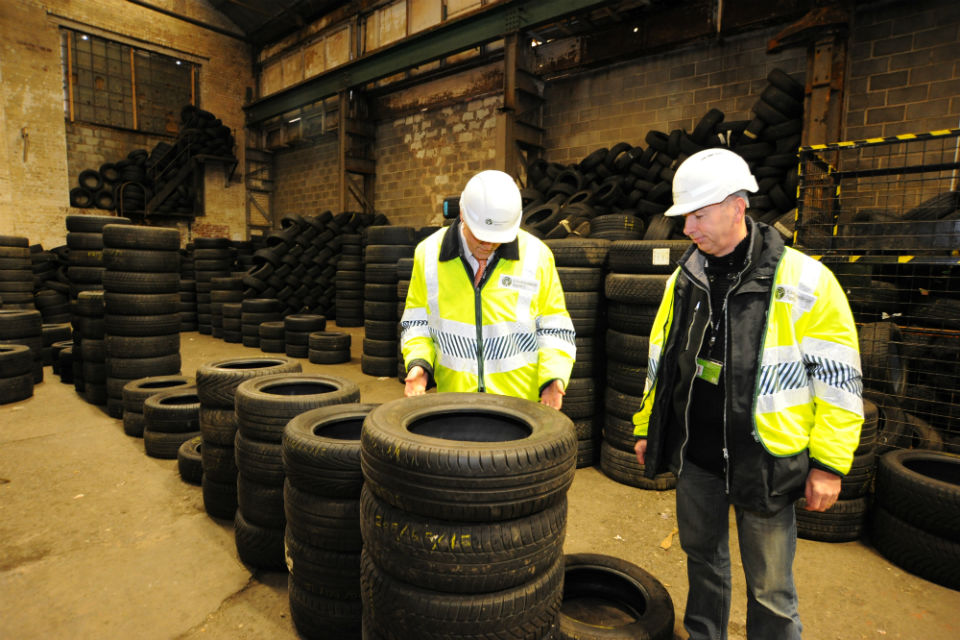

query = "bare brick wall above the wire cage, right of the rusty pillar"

[{"left": 844, "top": 0, "right": 960, "bottom": 140}]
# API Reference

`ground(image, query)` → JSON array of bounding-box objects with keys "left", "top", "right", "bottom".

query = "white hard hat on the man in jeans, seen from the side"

[{"left": 663, "top": 148, "right": 759, "bottom": 216}]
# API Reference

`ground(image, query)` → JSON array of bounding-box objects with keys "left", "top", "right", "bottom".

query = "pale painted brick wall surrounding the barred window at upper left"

[{"left": 0, "top": 0, "right": 253, "bottom": 247}]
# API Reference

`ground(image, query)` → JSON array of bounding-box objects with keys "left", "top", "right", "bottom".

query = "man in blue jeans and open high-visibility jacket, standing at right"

[{"left": 633, "top": 149, "right": 863, "bottom": 640}]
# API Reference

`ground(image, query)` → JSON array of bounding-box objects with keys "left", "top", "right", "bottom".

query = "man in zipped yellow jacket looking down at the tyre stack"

[{"left": 400, "top": 171, "right": 576, "bottom": 409}]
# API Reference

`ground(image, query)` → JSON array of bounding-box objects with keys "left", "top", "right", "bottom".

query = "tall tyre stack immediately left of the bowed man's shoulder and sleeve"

[{"left": 360, "top": 226, "right": 416, "bottom": 377}]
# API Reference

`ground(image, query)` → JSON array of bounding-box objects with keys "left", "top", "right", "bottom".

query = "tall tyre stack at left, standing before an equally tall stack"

[{"left": 103, "top": 225, "right": 180, "bottom": 418}]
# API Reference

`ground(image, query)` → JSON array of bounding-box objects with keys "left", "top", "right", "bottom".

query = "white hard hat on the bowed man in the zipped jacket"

[{"left": 460, "top": 171, "right": 523, "bottom": 244}]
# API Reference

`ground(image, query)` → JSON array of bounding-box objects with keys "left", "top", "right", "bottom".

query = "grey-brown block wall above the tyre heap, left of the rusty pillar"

[{"left": 544, "top": 30, "right": 806, "bottom": 169}]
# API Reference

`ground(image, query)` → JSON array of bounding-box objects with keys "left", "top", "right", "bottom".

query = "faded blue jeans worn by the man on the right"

[{"left": 677, "top": 460, "right": 803, "bottom": 640}]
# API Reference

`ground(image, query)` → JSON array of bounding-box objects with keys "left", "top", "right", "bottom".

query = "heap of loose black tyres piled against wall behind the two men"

[{"left": 521, "top": 69, "right": 804, "bottom": 245}]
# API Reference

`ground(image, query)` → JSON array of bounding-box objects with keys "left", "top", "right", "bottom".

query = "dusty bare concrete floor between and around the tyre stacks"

[{"left": 0, "top": 329, "right": 960, "bottom": 640}]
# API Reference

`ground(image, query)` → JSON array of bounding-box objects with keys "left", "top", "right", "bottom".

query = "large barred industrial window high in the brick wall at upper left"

[{"left": 60, "top": 29, "right": 200, "bottom": 135}]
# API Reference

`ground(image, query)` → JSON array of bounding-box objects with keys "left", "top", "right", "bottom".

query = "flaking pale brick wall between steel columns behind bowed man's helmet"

[{"left": 375, "top": 96, "right": 502, "bottom": 227}]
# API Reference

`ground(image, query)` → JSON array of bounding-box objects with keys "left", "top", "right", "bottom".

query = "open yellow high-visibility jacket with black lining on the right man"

[{"left": 633, "top": 221, "right": 863, "bottom": 510}]
